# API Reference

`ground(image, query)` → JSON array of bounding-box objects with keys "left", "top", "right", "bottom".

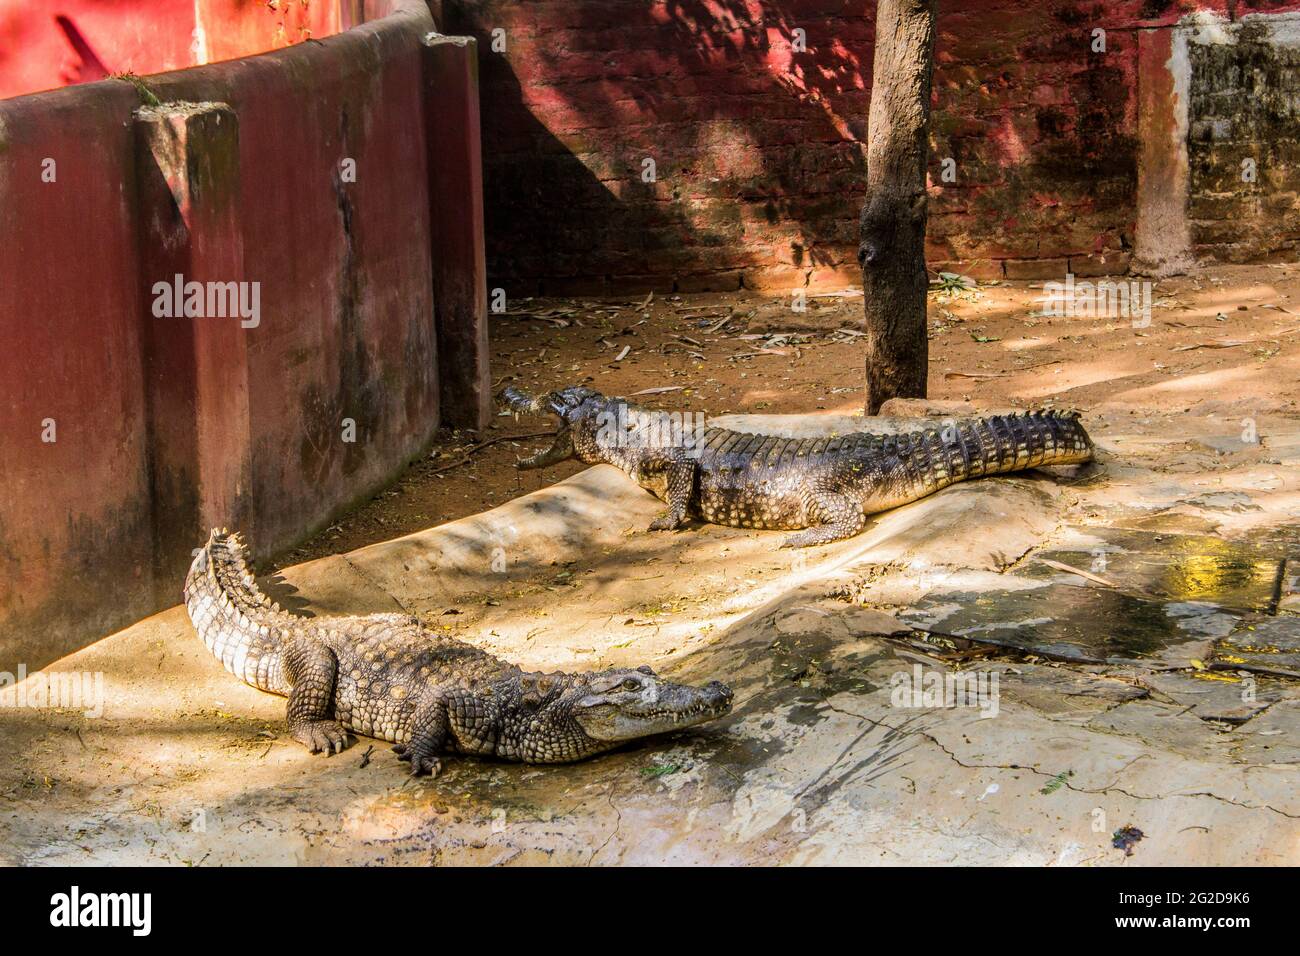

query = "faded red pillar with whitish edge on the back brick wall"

[{"left": 1132, "top": 26, "right": 1196, "bottom": 277}]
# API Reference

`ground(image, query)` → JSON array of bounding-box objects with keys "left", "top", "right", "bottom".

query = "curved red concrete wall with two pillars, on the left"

[{"left": 0, "top": 0, "right": 489, "bottom": 671}]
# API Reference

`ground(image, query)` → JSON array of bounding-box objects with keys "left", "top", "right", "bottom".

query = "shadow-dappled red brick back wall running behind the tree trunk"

[{"left": 445, "top": 0, "right": 1300, "bottom": 295}]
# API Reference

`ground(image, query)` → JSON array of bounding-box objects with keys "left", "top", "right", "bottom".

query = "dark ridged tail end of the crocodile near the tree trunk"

[{"left": 944, "top": 411, "right": 1092, "bottom": 481}]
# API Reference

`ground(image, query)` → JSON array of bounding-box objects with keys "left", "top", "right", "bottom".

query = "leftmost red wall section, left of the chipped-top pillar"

[{"left": 0, "top": 83, "right": 153, "bottom": 658}]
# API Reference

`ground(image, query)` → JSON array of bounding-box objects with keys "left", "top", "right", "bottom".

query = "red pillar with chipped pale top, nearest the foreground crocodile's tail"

[{"left": 135, "top": 103, "right": 260, "bottom": 598}]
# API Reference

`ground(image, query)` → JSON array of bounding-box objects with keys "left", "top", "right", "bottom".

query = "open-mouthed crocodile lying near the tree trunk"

[{"left": 501, "top": 385, "right": 1092, "bottom": 548}]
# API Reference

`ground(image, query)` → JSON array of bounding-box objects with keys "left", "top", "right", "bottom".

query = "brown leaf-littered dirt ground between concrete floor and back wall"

[{"left": 292, "top": 264, "right": 1300, "bottom": 563}]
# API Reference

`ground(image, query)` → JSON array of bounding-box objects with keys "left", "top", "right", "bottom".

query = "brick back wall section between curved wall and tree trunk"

[{"left": 445, "top": 0, "right": 872, "bottom": 295}]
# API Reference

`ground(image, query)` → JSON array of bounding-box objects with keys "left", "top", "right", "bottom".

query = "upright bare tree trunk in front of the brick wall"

[{"left": 858, "top": 0, "right": 935, "bottom": 415}]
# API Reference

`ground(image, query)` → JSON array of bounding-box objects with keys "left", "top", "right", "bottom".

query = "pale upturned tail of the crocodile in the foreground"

[{"left": 185, "top": 528, "right": 298, "bottom": 692}]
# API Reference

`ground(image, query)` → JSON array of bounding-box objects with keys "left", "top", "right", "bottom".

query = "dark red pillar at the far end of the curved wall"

[{"left": 424, "top": 34, "right": 493, "bottom": 431}]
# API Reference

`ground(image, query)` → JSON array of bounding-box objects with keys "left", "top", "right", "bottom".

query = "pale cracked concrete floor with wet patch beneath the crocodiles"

[{"left": 0, "top": 407, "right": 1300, "bottom": 866}]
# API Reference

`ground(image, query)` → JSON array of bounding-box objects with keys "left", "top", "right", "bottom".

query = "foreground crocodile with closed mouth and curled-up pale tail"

[{"left": 185, "top": 529, "right": 732, "bottom": 777}]
